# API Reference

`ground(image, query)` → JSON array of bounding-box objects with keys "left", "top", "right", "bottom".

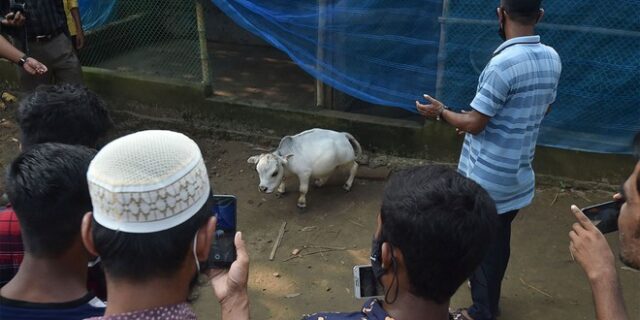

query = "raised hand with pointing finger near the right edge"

[{"left": 569, "top": 205, "right": 617, "bottom": 281}]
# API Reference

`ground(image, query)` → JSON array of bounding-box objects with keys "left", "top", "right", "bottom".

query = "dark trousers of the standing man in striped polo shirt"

[{"left": 469, "top": 210, "right": 518, "bottom": 320}]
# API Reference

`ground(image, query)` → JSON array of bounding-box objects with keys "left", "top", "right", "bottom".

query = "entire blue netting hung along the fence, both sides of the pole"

[{"left": 212, "top": 0, "right": 640, "bottom": 153}]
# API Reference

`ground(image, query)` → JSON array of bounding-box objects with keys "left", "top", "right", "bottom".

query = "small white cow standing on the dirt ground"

[{"left": 247, "top": 129, "right": 362, "bottom": 209}]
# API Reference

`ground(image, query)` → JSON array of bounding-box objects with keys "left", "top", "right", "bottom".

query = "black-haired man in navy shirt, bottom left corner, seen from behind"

[{"left": 0, "top": 143, "right": 105, "bottom": 320}]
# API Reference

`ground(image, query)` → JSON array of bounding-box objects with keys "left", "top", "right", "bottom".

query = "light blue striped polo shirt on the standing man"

[{"left": 458, "top": 36, "right": 562, "bottom": 213}]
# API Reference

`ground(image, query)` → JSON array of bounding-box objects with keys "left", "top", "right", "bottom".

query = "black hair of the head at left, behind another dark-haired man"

[{"left": 17, "top": 84, "right": 113, "bottom": 149}]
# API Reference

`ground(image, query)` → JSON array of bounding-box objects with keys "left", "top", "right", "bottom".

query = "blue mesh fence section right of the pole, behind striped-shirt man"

[{"left": 442, "top": 0, "right": 640, "bottom": 153}]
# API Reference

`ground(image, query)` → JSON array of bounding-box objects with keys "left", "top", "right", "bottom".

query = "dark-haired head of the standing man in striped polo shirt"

[{"left": 497, "top": 0, "right": 544, "bottom": 40}]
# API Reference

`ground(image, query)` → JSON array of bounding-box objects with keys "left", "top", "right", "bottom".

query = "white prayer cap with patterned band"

[{"left": 87, "top": 130, "right": 211, "bottom": 233}]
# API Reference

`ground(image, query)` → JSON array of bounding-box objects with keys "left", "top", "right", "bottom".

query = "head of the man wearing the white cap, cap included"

[{"left": 82, "top": 131, "right": 215, "bottom": 292}]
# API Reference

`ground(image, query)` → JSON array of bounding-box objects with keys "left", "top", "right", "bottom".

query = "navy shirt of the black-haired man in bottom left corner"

[{"left": 0, "top": 294, "right": 106, "bottom": 320}]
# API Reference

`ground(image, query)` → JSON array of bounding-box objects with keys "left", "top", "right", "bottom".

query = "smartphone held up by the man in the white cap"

[{"left": 207, "top": 195, "right": 238, "bottom": 269}]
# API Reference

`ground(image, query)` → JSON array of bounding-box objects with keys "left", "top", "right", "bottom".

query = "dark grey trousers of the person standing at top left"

[{"left": 18, "top": 33, "right": 82, "bottom": 91}]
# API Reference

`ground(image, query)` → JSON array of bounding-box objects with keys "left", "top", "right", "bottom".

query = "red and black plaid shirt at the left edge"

[{"left": 0, "top": 205, "right": 24, "bottom": 287}]
